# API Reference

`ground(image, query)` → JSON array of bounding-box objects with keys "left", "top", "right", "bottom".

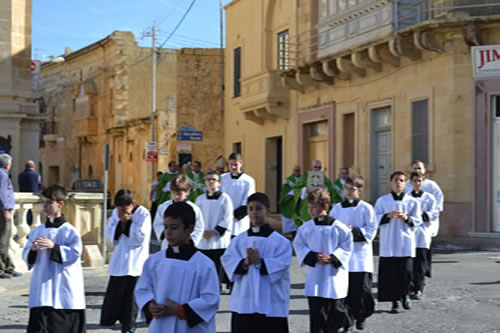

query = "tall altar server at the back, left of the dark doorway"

[{"left": 221, "top": 153, "right": 255, "bottom": 236}]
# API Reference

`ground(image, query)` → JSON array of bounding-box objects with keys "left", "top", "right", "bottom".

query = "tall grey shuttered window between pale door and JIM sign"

[{"left": 411, "top": 99, "right": 429, "bottom": 162}]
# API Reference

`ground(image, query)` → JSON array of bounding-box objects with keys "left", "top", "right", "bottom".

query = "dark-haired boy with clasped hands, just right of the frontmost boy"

[{"left": 221, "top": 192, "right": 292, "bottom": 333}]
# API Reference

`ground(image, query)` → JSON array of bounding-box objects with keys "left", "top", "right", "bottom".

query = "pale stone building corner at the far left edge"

[{"left": 0, "top": 0, "right": 43, "bottom": 189}]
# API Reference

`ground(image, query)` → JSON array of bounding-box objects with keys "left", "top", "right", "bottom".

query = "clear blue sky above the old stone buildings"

[{"left": 32, "top": 0, "right": 231, "bottom": 60}]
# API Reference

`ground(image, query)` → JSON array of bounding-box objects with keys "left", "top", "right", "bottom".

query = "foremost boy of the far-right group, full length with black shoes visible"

[{"left": 375, "top": 171, "right": 422, "bottom": 313}]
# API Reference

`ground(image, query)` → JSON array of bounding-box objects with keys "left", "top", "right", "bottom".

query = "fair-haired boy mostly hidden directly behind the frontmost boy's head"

[{"left": 153, "top": 174, "right": 205, "bottom": 250}]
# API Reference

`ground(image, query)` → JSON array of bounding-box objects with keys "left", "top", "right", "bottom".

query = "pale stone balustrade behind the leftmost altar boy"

[{"left": 9, "top": 192, "right": 104, "bottom": 271}]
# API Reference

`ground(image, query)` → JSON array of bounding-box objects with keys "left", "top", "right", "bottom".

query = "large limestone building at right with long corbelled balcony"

[{"left": 226, "top": 0, "right": 500, "bottom": 239}]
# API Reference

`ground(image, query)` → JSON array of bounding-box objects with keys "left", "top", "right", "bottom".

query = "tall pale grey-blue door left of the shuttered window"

[{"left": 370, "top": 106, "right": 392, "bottom": 202}]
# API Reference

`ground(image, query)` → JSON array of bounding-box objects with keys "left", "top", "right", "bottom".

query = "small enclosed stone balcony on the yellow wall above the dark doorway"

[{"left": 240, "top": 70, "right": 290, "bottom": 124}]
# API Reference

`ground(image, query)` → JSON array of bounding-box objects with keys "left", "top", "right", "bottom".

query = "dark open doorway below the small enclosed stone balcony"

[{"left": 265, "top": 136, "right": 283, "bottom": 213}]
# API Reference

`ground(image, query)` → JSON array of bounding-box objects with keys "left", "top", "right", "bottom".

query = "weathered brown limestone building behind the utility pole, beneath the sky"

[{"left": 39, "top": 31, "right": 222, "bottom": 204}]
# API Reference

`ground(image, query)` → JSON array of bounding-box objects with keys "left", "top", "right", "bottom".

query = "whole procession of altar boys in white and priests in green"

[{"left": 0, "top": 153, "right": 443, "bottom": 333}]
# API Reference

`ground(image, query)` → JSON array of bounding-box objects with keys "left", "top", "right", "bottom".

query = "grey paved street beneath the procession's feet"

[{"left": 0, "top": 249, "right": 500, "bottom": 333}]
